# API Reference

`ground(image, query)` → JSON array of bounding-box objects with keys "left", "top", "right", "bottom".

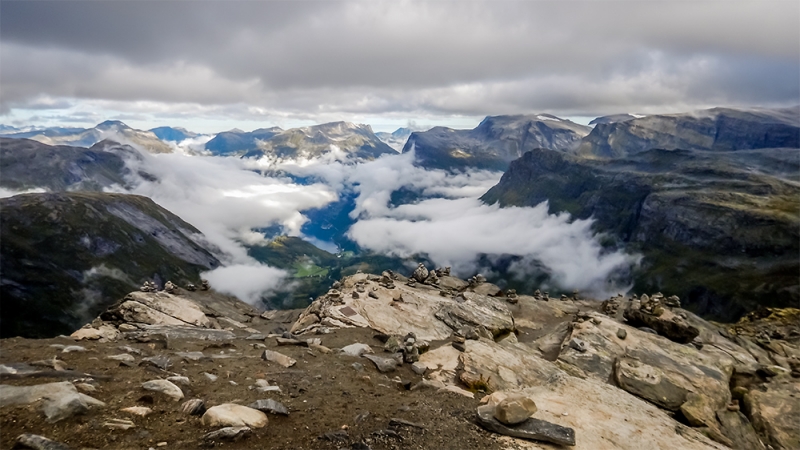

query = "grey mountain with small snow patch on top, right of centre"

[{"left": 403, "top": 114, "right": 591, "bottom": 170}]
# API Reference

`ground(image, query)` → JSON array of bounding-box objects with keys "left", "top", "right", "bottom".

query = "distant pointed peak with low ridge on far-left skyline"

[{"left": 3, "top": 120, "right": 172, "bottom": 153}]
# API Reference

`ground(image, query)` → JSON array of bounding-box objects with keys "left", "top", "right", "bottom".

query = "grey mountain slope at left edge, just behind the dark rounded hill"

[{"left": 0, "top": 138, "right": 140, "bottom": 191}]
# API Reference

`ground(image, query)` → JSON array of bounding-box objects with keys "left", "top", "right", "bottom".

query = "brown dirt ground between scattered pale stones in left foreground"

[{"left": 0, "top": 325, "right": 510, "bottom": 450}]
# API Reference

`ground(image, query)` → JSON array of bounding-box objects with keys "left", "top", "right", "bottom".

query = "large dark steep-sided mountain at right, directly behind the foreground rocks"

[{"left": 482, "top": 149, "right": 800, "bottom": 319}]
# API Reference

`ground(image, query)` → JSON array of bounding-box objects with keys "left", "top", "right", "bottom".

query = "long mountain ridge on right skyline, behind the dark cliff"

[{"left": 580, "top": 107, "right": 800, "bottom": 158}]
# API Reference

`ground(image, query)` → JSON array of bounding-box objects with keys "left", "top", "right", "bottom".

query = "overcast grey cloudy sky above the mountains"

[{"left": 0, "top": 0, "right": 800, "bottom": 132}]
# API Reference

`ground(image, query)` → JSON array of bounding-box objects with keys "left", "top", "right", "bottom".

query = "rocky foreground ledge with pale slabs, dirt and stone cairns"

[{"left": 0, "top": 266, "right": 800, "bottom": 450}]
